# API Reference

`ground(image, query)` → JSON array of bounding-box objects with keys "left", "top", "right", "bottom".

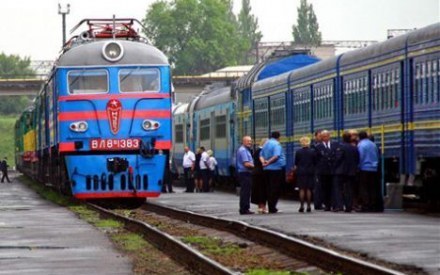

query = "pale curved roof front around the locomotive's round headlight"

[{"left": 56, "top": 40, "right": 168, "bottom": 67}]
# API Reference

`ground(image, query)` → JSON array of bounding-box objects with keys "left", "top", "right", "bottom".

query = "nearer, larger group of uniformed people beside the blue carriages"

[{"left": 236, "top": 130, "right": 383, "bottom": 217}]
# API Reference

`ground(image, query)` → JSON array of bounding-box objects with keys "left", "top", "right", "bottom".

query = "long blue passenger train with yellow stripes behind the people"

[{"left": 173, "top": 23, "right": 440, "bottom": 198}]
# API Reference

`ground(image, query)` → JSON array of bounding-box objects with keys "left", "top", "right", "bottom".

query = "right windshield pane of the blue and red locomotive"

[{"left": 119, "top": 68, "right": 160, "bottom": 93}]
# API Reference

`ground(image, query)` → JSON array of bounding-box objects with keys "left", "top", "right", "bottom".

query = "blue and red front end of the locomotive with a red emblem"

[{"left": 55, "top": 21, "right": 171, "bottom": 199}]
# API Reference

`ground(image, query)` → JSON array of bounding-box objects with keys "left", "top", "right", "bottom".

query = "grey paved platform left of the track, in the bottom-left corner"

[{"left": 0, "top": 174, "right": 132, "bottom": 275}]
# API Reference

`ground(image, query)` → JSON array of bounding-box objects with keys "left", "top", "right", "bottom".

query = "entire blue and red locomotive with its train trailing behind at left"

[{"left": 15, "top": 19, "right": 171, "bottom": 201}]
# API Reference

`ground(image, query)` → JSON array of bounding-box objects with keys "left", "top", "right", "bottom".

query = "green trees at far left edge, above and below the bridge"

[{"left": 0, "top": 53, "right": 35, "bottom": 115}]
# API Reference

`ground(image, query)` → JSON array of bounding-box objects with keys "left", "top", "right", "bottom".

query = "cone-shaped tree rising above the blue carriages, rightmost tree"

[{"left": 292, "top": 0, "right": 322, "bottom": 46}]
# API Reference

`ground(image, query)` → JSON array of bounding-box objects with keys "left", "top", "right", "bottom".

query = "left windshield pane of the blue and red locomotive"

[{"left": 67, "top": 70, "right": 108, "bottom": 95}]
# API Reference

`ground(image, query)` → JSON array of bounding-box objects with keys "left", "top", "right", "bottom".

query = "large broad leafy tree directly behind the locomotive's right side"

[{"left": 143, "top": 0, "right": 245, "bottom": 74}]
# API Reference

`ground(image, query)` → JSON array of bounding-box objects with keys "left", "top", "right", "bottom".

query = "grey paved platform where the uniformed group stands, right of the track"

[{"left": 148, "top": 187, "right": 440, "bottom": 274}]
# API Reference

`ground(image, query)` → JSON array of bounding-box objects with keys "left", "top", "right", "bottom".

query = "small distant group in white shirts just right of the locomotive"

[{"left": 183, "top": 146, "right": 217, "bottom": 193}]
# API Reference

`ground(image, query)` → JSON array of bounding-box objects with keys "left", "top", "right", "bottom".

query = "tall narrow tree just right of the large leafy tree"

[{"left": 238, "top": 0, "right": 263, "bottom": 64}]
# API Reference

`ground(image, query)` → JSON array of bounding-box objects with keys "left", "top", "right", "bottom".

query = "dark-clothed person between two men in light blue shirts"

[{"left": 251, "top": 138, "right": 268, "bottom": 214}]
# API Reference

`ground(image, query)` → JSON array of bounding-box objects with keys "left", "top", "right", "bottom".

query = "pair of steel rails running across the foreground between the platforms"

[{"left": 86, "top": 203, "right": 403, "bottom": 274}]
